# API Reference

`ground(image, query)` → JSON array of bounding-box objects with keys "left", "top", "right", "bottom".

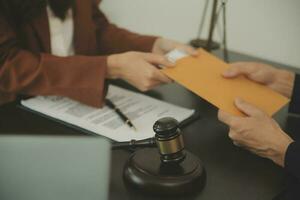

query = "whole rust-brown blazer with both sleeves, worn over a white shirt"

[{"left": 0, "top": 0, "right": 156, "bottom": 107}]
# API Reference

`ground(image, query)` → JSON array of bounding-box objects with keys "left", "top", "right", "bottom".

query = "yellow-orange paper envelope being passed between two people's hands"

[{"left": 162, "top": 49, "right": 289, "bottom": 116}]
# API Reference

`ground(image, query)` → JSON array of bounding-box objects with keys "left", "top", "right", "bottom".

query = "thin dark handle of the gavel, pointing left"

[{"left": 112, "top": 137, "right": 156, "bottom": 150}]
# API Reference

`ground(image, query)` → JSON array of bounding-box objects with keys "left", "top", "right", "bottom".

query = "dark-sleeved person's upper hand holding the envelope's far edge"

[{"left": 223, "top": 62, "right": 295, "bottom": 98}]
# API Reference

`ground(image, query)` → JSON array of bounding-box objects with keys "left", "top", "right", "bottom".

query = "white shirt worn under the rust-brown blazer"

[{"left": 47, "top": 6, "right": 75, "bottom": 57}]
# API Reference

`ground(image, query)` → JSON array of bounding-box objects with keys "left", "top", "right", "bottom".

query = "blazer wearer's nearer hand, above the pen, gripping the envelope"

[{"left": 107, "top": 52, "right": 174, "bottom": 91}]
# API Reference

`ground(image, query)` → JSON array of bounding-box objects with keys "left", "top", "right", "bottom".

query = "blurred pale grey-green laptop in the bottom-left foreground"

[{"left": 0, "top": 136, "right": 110, "bottom": 200}]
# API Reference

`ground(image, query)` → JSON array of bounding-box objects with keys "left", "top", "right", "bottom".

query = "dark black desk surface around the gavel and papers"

[{"left": 0, "top": 53, "right": 300, "bottom": 200}]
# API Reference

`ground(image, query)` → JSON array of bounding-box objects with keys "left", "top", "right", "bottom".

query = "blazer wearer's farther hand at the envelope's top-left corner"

[{"left": 152, "top": 38, "right": 197, "bottom": 56}]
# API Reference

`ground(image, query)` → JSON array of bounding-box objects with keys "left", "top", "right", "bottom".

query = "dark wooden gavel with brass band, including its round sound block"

[{"left": 113, "top": 117, "right": 206, "bottom": 195}]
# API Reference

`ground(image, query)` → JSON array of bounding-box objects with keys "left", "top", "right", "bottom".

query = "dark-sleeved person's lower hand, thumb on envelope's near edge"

[{"left": 218, "top": 99, "right": 293, "bottom": 167}]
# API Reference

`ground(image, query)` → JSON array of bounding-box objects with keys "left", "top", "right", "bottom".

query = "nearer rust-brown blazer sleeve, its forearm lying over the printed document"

[{"left": 0, "top": 15, "right": 106, "bottom": 106}]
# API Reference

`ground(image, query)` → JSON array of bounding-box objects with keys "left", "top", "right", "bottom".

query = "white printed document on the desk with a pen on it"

[{"left": 21, "top": 85, "right": 194, "bottom": 142}]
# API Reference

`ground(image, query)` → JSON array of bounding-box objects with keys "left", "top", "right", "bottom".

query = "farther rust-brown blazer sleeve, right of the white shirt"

[{"left": 93, "top": 0, "right": 157, "bottom": 54}]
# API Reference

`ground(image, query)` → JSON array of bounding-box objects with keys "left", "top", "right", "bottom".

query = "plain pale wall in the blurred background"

[{"left": 101, "top": 0, "right": 300, "bottom": 68}]
